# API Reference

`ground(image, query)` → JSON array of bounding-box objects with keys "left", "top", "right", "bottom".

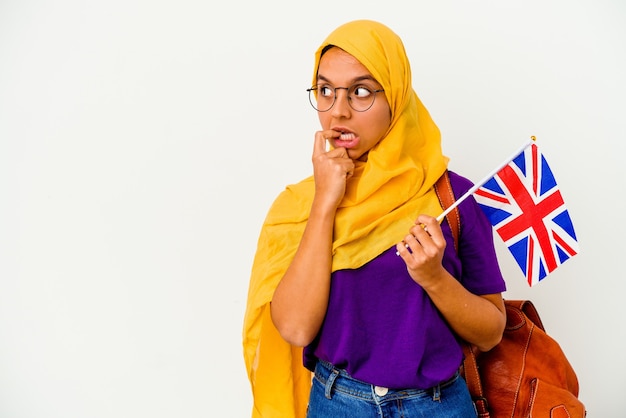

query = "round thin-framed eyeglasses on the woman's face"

[{"left": 306, "top": 84, "right": 385, "bottom": 112}]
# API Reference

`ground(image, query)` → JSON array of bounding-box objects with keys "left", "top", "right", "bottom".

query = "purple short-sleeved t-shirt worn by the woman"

[{"left": 304, "top": 172, "right": 506, "bottom": 389}]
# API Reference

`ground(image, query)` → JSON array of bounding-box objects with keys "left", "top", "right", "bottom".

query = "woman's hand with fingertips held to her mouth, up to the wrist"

[{"left": 312, "top": 130, "right": 354, "bottom": 209}]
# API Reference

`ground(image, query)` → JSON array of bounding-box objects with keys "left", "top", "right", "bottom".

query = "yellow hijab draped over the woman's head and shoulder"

[{"left": 243, "top": 20, "right": 448, "bottom": 418}]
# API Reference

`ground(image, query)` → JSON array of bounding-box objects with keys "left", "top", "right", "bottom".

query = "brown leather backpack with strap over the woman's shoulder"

[{"left": 435, "top": 171, "right": 587, "bottom": 418}]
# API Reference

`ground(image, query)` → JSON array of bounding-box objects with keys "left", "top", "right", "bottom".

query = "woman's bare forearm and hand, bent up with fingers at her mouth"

[{"left": 271, "top": 130, "right": 354, "bottom": 347}]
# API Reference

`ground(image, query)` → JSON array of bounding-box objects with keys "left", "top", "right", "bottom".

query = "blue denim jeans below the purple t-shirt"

[{"left": 307, "top": 361, "right": 477, "bottom": 418}]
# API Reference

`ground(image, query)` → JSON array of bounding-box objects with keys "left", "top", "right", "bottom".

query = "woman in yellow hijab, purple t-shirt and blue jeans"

[{"left": 244, "top": 20, "right": 506, "bottom": 418}]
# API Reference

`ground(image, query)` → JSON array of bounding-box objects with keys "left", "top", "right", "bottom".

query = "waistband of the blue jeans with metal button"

[{"left": 315, "top": 360, "right": 459, "bottom": 400}]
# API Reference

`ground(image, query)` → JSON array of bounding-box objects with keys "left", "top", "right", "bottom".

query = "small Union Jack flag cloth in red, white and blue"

[{"left": 474, "top": 143, "right": 579, "bottom": 286}]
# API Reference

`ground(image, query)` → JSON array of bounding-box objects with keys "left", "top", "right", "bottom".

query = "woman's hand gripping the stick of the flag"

[{"left": 396, "top": 215, "right": 446, "bottom": 288}]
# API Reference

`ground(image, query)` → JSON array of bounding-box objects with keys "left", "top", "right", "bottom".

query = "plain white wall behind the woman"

[{"left": 0, "top": 0, "right": 626, "bottom": 418}]
